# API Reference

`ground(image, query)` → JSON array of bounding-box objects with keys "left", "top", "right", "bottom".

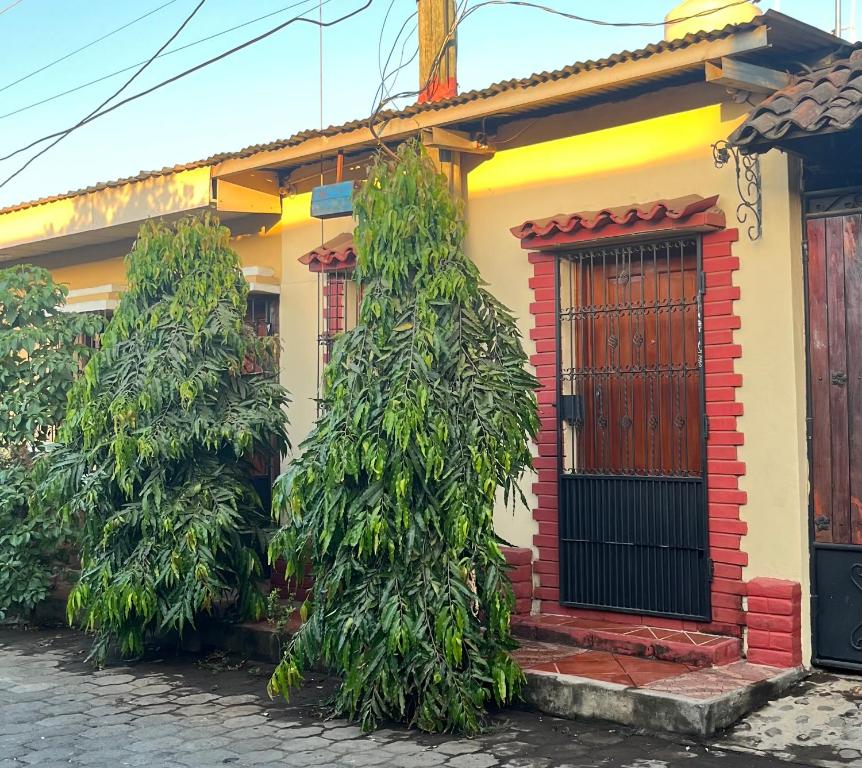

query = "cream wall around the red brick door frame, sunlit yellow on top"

[{"left": 467, "top": 85, "right": 808, "bottom": 656}]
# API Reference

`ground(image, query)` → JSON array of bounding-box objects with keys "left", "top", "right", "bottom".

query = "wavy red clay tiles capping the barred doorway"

[{"left": 511, "top": 195, "right": 718, "bottom": 240}]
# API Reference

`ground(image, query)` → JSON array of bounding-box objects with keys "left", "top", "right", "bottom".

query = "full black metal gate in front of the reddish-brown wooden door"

[{"left": 557, "top": 237, "right": 710, "bottom": 619}]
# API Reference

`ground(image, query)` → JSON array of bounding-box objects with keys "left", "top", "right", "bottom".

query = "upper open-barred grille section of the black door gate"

[{"left": 559, "top": 238, "right": 703, "bottom": 477}]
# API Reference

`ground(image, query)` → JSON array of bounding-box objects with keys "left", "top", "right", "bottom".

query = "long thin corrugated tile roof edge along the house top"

[{"left": 0, "top": 19, "right": 765, "bottom": 214}]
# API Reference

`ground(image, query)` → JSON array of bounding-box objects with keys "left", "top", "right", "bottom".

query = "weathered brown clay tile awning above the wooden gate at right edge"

[{"left": 728, "top": 47, "right": 862, "bottom": 152}]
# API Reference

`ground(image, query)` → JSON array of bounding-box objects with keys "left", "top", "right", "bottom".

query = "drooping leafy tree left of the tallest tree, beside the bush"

[{"left": 45, "top": 216, "right": 287, "bottom": 662}]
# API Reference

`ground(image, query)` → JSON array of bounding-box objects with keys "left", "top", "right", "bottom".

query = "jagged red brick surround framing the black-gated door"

[{"left": 529, "top": 229, "right": 748, "bottom": 637}]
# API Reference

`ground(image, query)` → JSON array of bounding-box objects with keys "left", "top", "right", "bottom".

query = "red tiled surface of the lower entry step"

[{"left": 513, "top": 640, "right": 782, "bottom": 699}]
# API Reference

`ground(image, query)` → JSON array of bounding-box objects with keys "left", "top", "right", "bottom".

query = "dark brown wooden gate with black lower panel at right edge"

[{"left": 806, "top": 193, "right": 862, "bottom": 668}]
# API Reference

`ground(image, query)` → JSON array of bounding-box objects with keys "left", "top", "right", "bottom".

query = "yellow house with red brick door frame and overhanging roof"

[{"left": 0, "top": 5, "right": 862, "bottom": 667}]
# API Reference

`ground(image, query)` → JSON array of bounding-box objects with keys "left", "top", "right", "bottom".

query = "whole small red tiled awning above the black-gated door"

[{"left": 511, "top": 195, "right": 724, "bottom": 248}]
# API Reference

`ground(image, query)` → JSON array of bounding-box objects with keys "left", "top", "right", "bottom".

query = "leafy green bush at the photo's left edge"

[{"left": 0, "top": 264, "right": 100, "bottom": 619}]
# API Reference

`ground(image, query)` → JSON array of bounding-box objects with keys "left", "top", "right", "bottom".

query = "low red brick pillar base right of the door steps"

[{"left": 747, "top": 579, "right": 802, "bottom": 667}]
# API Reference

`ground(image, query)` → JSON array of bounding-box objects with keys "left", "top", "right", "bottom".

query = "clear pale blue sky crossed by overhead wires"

[{"left": 0, "top": 0, "right": 850, "bottom": 205}]
